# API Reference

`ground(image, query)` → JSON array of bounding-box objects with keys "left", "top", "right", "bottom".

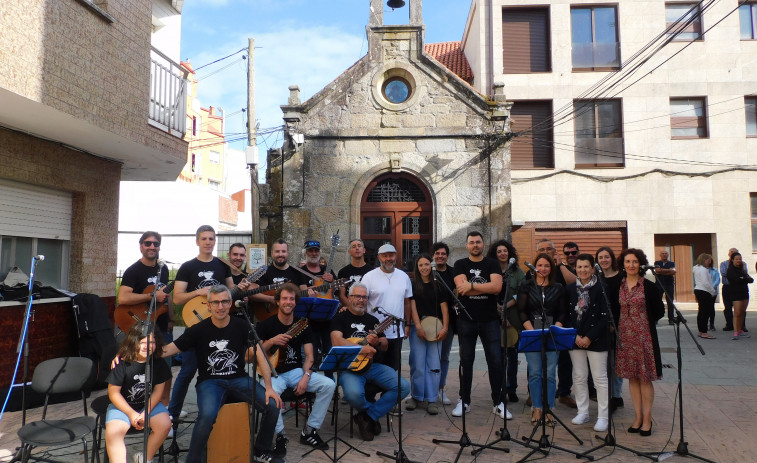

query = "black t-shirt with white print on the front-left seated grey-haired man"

[{"left": 174, "top": 317, "right": 249, "bottom": 383}]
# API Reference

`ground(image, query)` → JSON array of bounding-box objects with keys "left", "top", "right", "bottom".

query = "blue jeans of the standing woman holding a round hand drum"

[{"left": 410, "top": 326, "right": 442, "bottom": 402}]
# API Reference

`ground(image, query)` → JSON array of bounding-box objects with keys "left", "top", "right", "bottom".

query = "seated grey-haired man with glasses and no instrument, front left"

[{"left": 163, "top": 285, "right": 283, "bottom": 463}]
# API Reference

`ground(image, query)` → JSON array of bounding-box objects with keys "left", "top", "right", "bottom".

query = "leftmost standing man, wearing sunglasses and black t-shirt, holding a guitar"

[{"left": 118, "top": 231, "right": 173, "bottom": 406}]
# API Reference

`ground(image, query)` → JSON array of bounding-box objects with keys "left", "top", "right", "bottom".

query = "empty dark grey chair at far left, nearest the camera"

[{"left": 18, "top": 357, "right": 95, "bottom": 463}]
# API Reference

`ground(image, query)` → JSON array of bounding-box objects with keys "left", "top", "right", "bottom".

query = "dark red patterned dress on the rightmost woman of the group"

[{"left": 615, "top": 278, "right": 660, "bottom": 381}]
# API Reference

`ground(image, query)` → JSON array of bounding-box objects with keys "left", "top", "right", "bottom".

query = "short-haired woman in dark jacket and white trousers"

[{"left": 566, "top": 254, "right": 610, "bottom": 432}]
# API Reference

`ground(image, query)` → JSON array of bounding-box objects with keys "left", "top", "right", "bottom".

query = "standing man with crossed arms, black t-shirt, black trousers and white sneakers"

[{"left": 452, "top": 231, "right": 512, "bottom": 419}]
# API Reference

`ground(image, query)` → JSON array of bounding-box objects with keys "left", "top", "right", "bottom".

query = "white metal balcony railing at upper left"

[{"left": 149, "top": 48, "right": 187, "bottom": 137}]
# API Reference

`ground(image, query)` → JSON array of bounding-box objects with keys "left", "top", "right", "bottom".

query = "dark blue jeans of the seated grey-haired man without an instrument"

[{"left": 186, "top": 376, "right": 279, "bottom": 463}]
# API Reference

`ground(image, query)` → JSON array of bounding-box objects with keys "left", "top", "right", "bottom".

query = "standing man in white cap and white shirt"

[{"left": 361, "top": 243, "right": 413, "bottom": 371}]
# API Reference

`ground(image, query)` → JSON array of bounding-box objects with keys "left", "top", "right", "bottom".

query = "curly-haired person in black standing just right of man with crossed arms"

[{"left": 486, "top": 240, "right": 526, "bottom": 403}]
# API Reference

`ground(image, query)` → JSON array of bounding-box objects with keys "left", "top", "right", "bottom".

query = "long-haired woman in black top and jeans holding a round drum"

[{"left": 405, "top": 254, "right": 449, "bottom": 415}]
